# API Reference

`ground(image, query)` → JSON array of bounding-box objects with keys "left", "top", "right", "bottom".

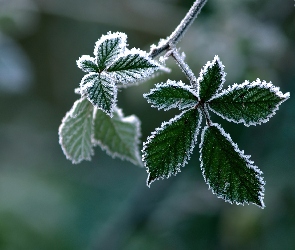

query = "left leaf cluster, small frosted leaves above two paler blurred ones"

[{"left": 59, "top": 32, "right": 160, "bottom": 166}]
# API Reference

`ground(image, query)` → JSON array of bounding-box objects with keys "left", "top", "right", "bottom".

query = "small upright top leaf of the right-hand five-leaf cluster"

[{"left": 197, "top": 56, "right": 226, "bottom": 102}]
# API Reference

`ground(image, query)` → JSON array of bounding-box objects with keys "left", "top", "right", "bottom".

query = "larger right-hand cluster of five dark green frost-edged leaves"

[{"left": 142, "top": 56, "right": 289, "bottom": 208}]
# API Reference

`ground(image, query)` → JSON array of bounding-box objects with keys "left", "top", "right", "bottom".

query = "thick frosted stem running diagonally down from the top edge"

[{"left": 149, "top": 0, "right": 207, "bottom": 58}]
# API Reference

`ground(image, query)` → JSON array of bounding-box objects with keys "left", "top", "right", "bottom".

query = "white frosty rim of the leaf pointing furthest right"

[{"left": 207, "top": 78, "right": 290, "bottom": 127}]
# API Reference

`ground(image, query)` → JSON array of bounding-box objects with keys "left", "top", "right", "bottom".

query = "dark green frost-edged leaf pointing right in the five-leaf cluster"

[{"left": 208, "top": 79, "right": 290, "bottom": 126}]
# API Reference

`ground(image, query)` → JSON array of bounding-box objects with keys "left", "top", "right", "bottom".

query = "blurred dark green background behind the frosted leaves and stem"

[{"left": 0, "top": 0, "right": 295, "bottom": 250}]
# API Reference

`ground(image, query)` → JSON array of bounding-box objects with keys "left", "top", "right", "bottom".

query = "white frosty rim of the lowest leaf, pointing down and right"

[{"left": 199, "top": 123, "right": 265, "bottom": 209}]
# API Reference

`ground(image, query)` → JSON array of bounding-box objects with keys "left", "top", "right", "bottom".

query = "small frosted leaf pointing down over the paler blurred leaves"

[{"left": 80, "top": 73, "right": 117, "bottom": 116}]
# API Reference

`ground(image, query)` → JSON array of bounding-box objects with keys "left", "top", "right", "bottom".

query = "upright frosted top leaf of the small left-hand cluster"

[{"left": 93, "top": 32, "right": 127, "bottom": 71}]
